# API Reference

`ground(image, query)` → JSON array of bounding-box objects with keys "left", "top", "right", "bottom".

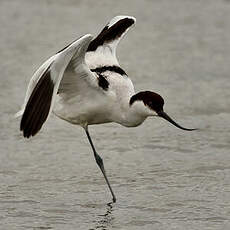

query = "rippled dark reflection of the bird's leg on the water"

[{"left": 90, "top": 202, "right": 113, "bottom": 230}]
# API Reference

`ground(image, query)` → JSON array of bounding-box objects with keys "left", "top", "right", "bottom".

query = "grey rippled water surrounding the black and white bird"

[{"left": 0, "top": 0, "right": 230, "bottom": 230}]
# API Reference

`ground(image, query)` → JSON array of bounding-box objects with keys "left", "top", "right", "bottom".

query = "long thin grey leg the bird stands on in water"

[{"left": 85, "top": 127, "right": 116, "bottom": 203}]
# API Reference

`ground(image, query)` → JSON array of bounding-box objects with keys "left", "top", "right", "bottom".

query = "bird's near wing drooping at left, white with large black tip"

[{"left": 17, "top": 35, "right": 93, "bottom": 138}]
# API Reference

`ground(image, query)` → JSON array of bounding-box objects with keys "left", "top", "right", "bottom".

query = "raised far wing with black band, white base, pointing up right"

[{"left": 86, "top": 16, "right": 136, "bottom": 69}]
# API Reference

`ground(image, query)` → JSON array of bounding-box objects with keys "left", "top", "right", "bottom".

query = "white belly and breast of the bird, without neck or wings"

[{"left": 53, "top": 73, "right": 140, "bottom": 126}]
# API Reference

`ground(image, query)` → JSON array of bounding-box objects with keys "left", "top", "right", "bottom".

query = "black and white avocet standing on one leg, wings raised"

[{"left": 17, "top": 16, "right": 194, "bottom": 202}]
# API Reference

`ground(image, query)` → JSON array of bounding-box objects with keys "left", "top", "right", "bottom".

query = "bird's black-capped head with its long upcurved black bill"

[{"left": 129, "top": 91, "right": 196, "bottom": 131}]
